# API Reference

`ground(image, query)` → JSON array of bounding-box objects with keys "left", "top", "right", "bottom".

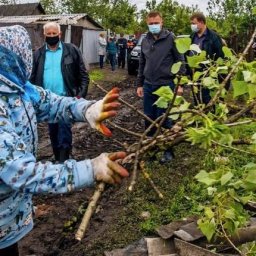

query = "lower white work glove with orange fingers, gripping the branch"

[{"left": 91, "top": 152, "right": 129, "bottom": 184}]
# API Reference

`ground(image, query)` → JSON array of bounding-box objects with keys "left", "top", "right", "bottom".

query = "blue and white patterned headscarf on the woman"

[{"left": 0, "top": 25, "right": 40, "bottom": 103}]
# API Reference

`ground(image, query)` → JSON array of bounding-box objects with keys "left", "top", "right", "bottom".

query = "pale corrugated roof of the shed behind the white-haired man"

[{"left": 0, "top": 13, "right": 102, "bottom": 28}]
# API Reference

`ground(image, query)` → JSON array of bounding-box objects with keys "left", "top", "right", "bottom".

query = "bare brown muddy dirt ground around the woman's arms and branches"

[{"left": 20, "top": 64, "right": 204, "bottom": 256}]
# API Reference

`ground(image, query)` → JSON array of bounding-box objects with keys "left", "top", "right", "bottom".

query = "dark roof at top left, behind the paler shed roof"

[{"left": 0, "top": 3, "right": 45, "bottom": 16}]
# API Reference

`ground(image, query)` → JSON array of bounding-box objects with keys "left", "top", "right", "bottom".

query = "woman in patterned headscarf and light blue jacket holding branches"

[{"left": 0, "top": 26, "right": 128, "bottom": 256}]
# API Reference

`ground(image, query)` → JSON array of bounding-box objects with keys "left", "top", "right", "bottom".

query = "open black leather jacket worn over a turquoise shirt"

[{"left": 30, "top": 42, "right": 89, "bottom": 98}]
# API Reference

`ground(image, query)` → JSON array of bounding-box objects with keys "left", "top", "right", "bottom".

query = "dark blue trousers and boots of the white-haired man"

[{"left": 48, "top": 122, "right": 72, "bottom": 162}]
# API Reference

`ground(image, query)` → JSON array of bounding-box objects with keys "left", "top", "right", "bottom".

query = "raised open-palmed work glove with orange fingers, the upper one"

[{"left": 85, "top": 87, "right": 120, "bottom": 136}]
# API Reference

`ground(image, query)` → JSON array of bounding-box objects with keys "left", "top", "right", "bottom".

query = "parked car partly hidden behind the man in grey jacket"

[{"left": 127, "top": 33, "right": 189, "bottom": 75}]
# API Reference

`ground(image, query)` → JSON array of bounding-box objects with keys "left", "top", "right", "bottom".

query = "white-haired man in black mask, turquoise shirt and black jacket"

[{"left": 30, "top": 22, "right": 89, "bottom": 162}]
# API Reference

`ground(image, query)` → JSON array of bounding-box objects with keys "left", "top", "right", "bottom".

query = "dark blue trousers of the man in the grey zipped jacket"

[{"left": 143, "top": 82, "right": 174, "bottom": 136}]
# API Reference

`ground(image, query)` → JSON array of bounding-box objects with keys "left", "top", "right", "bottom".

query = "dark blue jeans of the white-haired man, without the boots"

[{"left": 48, "top": 122, "right": 72, "bottom": 149}]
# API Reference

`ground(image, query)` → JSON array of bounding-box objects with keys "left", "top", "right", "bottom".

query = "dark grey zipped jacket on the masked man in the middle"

[{"left": 137, "top": 30, "right": 185, "bottom": 86}]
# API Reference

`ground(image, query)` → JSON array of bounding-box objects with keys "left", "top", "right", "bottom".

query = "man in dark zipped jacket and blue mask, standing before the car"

[{"left": 137, "top": 11, "right": 183, "bottom": 163}]
